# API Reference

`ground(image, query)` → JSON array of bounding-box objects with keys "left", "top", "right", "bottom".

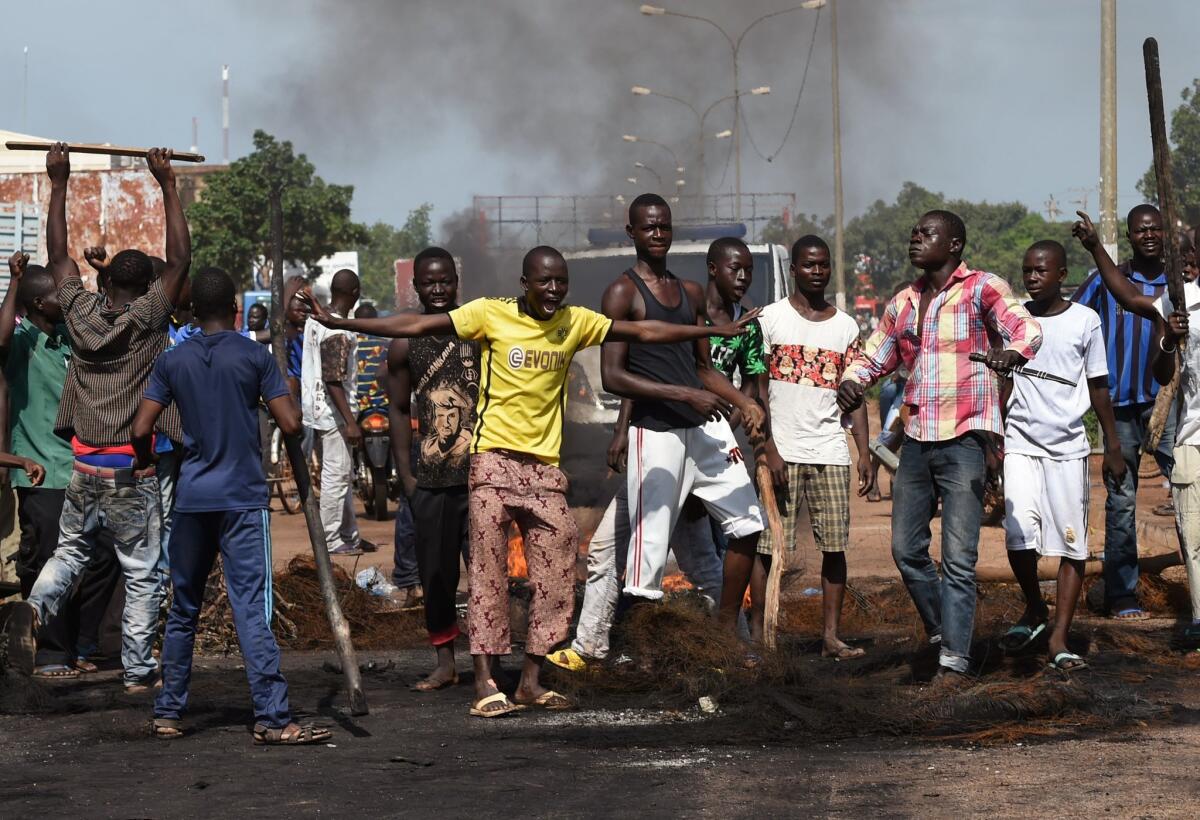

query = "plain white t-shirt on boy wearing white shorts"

[{"left": 1004, "top": 303, "right": 1109, "bottom": 461}]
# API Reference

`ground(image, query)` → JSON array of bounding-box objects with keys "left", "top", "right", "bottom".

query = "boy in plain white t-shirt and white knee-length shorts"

[{"left": 1000, "top": 240, "right": 1126, "bottom": 672}]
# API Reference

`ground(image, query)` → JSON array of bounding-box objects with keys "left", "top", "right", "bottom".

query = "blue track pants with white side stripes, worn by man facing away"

[{"left": 155, "top": 509, "right": 290, "bottom": 729}]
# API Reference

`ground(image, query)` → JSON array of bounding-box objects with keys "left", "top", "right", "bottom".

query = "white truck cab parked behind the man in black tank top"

[{"left": 562, "top": 239, "right": 791, "bottom": 504}]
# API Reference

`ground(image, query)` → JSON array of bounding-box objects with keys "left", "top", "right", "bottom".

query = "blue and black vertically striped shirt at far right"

[{"left": 1070, "top": 262, "right": 1166, "bottom": 407}]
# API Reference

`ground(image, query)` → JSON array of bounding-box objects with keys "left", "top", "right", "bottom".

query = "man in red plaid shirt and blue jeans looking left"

[{"left": 838, "top": 210, "right": 1042, "bottom": 681}]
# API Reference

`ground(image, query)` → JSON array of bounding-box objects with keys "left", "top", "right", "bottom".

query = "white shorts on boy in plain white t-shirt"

[{"left": 1004, "top": 453, "right": 1091, "bottom": 561}]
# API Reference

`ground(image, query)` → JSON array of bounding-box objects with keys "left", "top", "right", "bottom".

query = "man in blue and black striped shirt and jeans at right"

[{"left": 1072, "top": 204, "right": 1175, "bottom": 621}]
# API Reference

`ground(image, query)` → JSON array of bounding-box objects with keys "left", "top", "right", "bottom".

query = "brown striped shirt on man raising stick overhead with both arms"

[{"left": 54, "top": 275, "right": 184, "bottom": 447}]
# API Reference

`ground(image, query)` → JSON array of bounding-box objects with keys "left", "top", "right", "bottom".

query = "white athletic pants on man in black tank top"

[{"left": 625, "top": 419, "right": 763, "bottom": 598}]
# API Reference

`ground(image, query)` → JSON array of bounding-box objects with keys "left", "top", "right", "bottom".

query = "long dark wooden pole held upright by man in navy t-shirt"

[{"left": 270, "top": 187, "right": 367, "bottom": 714}]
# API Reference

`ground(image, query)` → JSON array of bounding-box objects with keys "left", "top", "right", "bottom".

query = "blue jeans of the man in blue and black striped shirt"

[{"left": 1104, "top": 402, "right": 1175, "bottom": 612}]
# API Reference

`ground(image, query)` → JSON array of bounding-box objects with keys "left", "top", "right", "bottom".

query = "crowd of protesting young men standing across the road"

[{"left": 0, "top": 144, "right": 1200, "bottom": 743}]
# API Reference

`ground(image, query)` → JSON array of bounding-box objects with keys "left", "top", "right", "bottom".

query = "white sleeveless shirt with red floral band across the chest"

[{"left": 758, "top": 299, "right": 859, "bottom": 465}]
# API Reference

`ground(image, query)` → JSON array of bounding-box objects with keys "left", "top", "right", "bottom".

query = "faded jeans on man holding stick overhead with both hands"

[{"left": 29, "top": 472, "right": 162, "bottom": 683}]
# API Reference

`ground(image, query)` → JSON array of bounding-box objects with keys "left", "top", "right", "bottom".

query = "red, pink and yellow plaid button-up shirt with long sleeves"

[{"left": 844, "top": 264, "right": 1042, "bottom": 442}]
